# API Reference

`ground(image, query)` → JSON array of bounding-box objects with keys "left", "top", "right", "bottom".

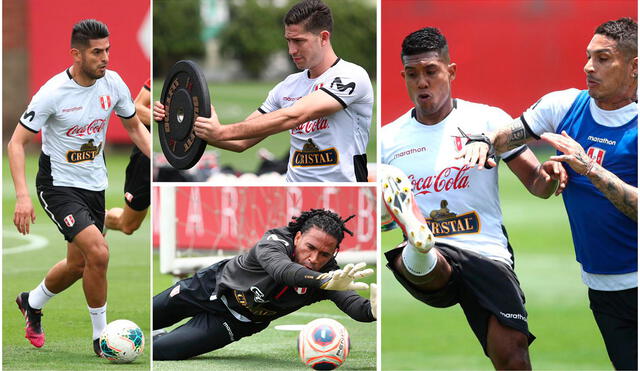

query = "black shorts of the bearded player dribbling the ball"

[{"left": 37, "top": 185, "right": 105, "bottom": 242}]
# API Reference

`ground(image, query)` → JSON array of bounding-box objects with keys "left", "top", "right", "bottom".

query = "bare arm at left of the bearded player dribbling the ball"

[{"left": 7, "top": 124, "right": 36, "bottom": 234}]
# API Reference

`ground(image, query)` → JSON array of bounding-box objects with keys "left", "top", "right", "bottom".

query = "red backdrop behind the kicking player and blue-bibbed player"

[{"left": 381, "top": 0, "right": 638, "bottom": 125}]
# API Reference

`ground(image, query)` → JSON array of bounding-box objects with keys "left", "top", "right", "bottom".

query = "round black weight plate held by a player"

[{"left": 157, "top": 60, "right": 211, "bottom": 169}]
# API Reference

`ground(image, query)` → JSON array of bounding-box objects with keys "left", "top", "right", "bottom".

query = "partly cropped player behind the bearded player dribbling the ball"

[{"left": 104, "top": 79, "right": 151, "bottom": 234}]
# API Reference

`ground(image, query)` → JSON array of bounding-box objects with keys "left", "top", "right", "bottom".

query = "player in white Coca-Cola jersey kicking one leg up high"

[{"left": 378, "top": 28, "right": 558, "bottom": 370}]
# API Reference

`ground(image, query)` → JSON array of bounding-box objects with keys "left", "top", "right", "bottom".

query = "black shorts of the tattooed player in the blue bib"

[{"left": 589, "top": 287, "right": 638, "bottom": 370}]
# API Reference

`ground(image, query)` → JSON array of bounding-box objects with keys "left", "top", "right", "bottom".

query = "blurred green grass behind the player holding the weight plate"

[{"left": 153, "top": 79, "right": 377, "bottom": 172}]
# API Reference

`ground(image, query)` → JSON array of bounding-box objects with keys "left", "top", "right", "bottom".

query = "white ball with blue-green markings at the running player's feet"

[{"left": 100, "top": 319, "right": 144, "bottom": 363}]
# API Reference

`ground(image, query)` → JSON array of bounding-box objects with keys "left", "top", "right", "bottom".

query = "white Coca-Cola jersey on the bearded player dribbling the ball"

[{"left": 20, "top": 69, "right": 136, "bottom": 191}]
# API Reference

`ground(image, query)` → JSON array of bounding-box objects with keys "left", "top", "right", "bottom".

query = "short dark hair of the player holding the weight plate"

[{"left": 284, "top": 0, "right": 333, "bottom": 34}]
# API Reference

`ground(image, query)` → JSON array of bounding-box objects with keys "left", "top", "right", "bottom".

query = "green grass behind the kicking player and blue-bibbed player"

[{"left": 382, "top": 152, "right": 612, "bottom": 370}]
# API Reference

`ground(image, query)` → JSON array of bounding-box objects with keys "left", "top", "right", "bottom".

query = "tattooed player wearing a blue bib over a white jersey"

[{"left": 461, "top": 18, "right": 638, "bottom": 370}]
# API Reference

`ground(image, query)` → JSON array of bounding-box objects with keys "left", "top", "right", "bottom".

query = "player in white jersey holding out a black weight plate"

[{"left": 154, "top": 0, "right": 373, "bottom": 182}]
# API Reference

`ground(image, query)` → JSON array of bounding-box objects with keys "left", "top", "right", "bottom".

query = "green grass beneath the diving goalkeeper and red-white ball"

[{"left": 153, "top": 255, "right": 376, "bottom": 371}]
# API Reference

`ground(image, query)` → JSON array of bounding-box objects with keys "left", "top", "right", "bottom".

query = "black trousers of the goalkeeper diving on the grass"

[{"left": 153, "top": 264, "right": 269, "bottom": 360}]
